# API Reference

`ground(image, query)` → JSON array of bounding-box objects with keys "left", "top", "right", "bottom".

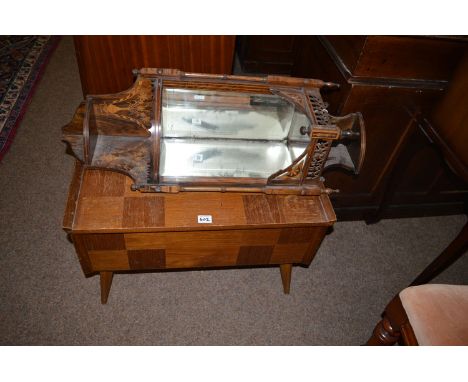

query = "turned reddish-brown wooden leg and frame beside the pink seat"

[{"left": 366, "top": 295, "right": 418, "bottom": 346}]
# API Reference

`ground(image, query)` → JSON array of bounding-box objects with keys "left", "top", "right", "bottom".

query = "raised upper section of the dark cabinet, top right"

[{"left": 326, "top": 36, "right": 465, "bottom": 81}]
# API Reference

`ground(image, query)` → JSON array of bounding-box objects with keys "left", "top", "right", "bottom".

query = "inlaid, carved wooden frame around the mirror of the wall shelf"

[{"left": 63, "top": 68, "right": 365, "bottom": 195}]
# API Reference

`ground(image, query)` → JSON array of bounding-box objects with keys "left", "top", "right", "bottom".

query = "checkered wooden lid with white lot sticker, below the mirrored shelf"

[{"left": 72, "top": 169, "right": 336, "bottom": 233}]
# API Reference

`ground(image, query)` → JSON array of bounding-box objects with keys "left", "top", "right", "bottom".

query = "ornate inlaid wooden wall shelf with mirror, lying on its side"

[{"left": 63, "top": 68, "right": 365, "bottom": 195}]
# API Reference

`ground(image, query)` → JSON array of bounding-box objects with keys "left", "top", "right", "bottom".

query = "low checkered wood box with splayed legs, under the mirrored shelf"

[{"left": 64, "top": 161, "right": 336, "bottom": 303}]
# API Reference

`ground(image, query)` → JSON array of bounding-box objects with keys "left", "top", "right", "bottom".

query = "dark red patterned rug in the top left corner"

[{"left": 0, "top": 36, "right": 60, "bottom": 160}]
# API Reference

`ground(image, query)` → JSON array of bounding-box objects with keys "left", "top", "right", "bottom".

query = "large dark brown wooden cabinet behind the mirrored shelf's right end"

[{"left": 238, "top": 36, "right": 468, "bottom": 219}]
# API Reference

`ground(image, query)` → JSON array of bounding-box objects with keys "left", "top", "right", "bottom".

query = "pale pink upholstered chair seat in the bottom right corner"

[{"left": 400, "top": 284, "right": 468, "bottom": 345}]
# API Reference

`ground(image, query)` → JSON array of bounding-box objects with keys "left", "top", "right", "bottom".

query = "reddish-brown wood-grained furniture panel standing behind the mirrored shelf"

[{"left": 74, "top": 36, "right": 235, "bottom": 95}]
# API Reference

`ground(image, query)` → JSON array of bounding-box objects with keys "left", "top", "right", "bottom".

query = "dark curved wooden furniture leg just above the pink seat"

[{"left": 410, "top": 223, "right": 468, "bottom": 286}]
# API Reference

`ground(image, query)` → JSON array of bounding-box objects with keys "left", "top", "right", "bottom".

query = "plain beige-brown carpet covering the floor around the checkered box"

[{"left": 0, "top": 37, "right": 468, "bottom": 345}]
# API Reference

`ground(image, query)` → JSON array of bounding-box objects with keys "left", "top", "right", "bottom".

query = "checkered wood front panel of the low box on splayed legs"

[{"left": 76, "top": 227, "right": 326, "bottom": 273}]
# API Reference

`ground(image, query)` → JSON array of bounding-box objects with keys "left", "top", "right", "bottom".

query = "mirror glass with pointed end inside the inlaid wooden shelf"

[{"left": 160, "top": 88, "right": 310, "bottom": 178}]
